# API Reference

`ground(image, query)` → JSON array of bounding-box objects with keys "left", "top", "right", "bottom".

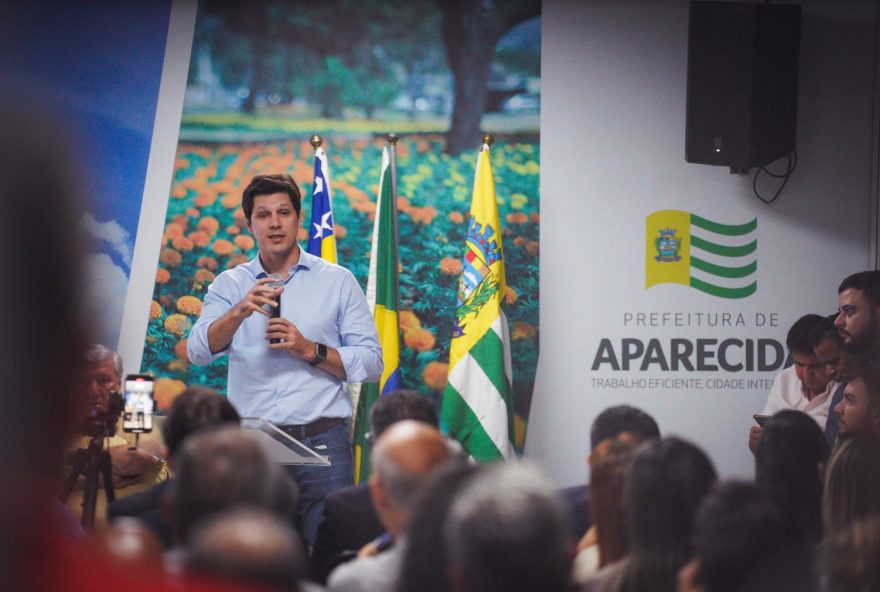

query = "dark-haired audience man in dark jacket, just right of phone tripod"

[{"left": 107, "top": 387, "right": 239, "bottom": 549}]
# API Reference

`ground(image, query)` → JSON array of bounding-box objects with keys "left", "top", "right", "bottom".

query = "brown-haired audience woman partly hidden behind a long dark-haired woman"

[{"left": 572, "top": 432, "right": 637, "bottom": 583}]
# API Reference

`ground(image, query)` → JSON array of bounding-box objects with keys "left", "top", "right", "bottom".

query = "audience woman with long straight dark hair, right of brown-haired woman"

[{"left": 584, "top": 437, "right": 716, "bottom": 592}]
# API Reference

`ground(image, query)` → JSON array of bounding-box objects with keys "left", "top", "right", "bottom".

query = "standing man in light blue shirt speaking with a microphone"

[{"left": 187, "top": 175, "right": 382, "bottom": 543}]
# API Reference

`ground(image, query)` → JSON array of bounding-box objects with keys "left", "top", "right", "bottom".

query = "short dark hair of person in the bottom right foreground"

[{"left": 693, "top": 482, "right": 785, "bottom": 592}]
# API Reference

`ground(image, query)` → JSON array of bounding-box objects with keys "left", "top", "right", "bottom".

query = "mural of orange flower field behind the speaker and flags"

[{"left": 142, "top": 1, "right": 540, "bottom": 444}]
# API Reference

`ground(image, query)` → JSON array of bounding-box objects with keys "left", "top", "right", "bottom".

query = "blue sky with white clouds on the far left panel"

[{"left": 0, "top": 0, "right": 171, "bottom": 346}]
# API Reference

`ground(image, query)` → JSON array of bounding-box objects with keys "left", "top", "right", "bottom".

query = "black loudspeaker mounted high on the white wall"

[{"left": 685, "top": 2, "right": 801, "bottom": 169}]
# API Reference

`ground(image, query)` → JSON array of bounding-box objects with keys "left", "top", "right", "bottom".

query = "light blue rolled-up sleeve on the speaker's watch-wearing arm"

[{"left": 336, "top": 275, "right": 384, "bottom": 384}]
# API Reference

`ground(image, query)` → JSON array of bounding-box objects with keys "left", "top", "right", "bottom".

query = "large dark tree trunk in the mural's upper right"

[{"left": 437, "top": 0, "right": 541, "bottom": 154}]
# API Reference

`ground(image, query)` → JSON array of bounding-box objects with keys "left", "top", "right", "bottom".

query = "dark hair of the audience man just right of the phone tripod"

[{"left": 162, "top": 387, "right": 241, "bottom": 457}]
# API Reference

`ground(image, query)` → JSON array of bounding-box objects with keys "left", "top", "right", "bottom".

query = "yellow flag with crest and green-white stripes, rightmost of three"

[{"left": 441, "top": 144, "right": 514, "bottom": 462}]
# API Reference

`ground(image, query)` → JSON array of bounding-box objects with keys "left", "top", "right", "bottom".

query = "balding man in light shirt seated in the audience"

[{"left": 327, "top": 420, "right": 450, "bottom": 592}]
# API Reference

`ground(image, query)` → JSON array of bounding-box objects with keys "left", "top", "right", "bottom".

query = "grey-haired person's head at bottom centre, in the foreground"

[{"left": 444, "top": 463, "right": 573, "bottom": 592}]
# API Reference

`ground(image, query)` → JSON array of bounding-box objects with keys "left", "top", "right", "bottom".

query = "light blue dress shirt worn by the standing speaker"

[{"left": 187, "top": 249, "right": 382, "bottom": 425}]
